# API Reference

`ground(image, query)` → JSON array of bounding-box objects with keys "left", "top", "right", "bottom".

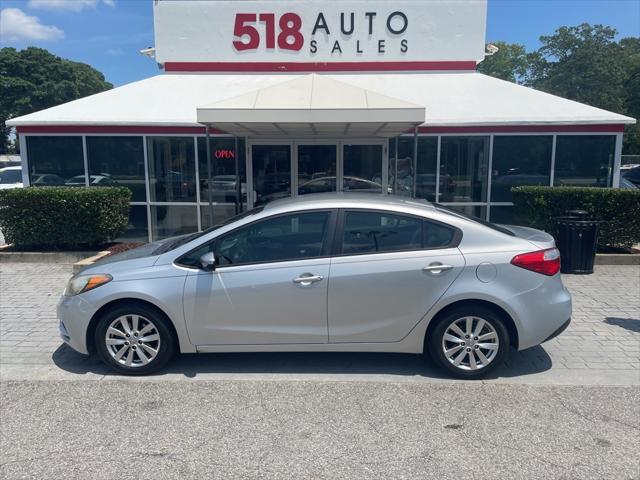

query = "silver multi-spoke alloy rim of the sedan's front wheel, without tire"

[{"left": 105, "top": 314, "right": 161, "bottom": 368}]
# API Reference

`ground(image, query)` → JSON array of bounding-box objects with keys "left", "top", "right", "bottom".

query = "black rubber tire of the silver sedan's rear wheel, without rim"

[{"left": 425, "top": 305, "right": 509, "bottom": 380}]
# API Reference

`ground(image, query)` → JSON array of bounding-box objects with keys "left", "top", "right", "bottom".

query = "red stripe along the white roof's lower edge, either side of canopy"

[{"left": 17, "top": 124, "right": 624, "bottom": 135}]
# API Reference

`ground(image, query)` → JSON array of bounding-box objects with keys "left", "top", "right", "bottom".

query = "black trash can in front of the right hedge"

[{"left": 555, "top": 210, "right": 599, "bottom": 274}]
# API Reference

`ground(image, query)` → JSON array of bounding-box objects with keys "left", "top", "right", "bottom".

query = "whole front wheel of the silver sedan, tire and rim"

[{"left": 95, "top": 305, "right": 175, "bottom": 375}]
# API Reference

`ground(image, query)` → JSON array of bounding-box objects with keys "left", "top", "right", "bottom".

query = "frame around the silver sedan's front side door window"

[{"left": 173, "top": 208, "right": 338, "bottom": 271}]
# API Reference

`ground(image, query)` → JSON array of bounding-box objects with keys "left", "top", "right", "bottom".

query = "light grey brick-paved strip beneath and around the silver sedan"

[{"left": 0, "top": 263, "right": 640, "bottom": 385}]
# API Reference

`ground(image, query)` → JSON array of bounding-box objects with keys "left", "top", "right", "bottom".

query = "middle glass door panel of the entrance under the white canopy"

[{"left": 296, "top": 143, "right": 338, "bottom": 195}]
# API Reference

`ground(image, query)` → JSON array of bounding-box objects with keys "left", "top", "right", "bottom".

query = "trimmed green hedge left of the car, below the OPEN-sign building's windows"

[{"left": 0, "top": 187, "right": 131, "bottom": 250}]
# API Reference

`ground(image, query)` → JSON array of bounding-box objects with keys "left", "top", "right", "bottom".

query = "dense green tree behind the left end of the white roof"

[{"left": 0, "top": 47, "right": 113, "bottom": 153}]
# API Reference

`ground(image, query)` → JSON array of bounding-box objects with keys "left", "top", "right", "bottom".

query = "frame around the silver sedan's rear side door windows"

[{"left": 331, "top": 208, "right": 462, "bottom": 257}]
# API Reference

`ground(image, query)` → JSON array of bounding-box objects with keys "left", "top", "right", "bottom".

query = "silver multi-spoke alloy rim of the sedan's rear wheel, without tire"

[{"left": 442, "top": 316, "right": 500, "bottom": 370}]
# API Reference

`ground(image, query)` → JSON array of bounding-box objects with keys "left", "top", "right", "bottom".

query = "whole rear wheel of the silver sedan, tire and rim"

[{"left": 427, "top": 307, "right": 509, "bottom": 379}]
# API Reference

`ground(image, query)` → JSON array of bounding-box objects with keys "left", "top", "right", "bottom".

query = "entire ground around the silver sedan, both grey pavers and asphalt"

[{"left": 0, "top": 263, "right": 640, "bottom": 479}]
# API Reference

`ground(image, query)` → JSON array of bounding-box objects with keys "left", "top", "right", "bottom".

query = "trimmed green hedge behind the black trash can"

[{"left": 511, "top": 187, "right": 640, "bottom": 248}]
